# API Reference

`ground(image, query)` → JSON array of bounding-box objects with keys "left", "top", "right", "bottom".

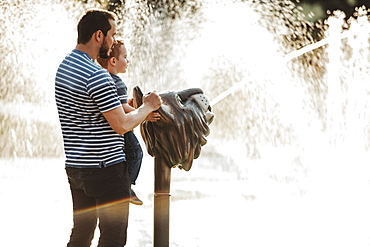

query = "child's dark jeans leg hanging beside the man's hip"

[{"left": 124, "top": 131, "right": 143, "bottom": 184}]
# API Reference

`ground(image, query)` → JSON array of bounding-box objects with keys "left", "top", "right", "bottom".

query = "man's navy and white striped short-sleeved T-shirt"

[{"left": 55, "top": 49, "right": 125, "bottom": 168}]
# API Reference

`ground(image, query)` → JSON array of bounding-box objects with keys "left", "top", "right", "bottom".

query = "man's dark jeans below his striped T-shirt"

[{"left": 66, "top": 162, "right": 130, "bottom": 247}]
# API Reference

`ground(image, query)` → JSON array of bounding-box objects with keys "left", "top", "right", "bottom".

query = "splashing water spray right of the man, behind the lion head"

[{"left": 126, "top": 1, "right": 369, "bottom": 165}]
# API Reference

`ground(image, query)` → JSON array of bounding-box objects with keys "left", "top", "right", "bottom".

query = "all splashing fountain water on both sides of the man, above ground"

[{"left": 0, "top": 0, "right": 368, "bottom": 157}]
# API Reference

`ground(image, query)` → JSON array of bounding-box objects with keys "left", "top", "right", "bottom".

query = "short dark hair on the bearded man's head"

[{"left": 77, "top": 9, "right": 117, "bottom": 44}]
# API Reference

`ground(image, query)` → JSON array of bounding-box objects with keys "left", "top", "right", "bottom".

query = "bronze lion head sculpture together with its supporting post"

[{"left": 133, "top": 86, "right": 214, "bottom": 247}]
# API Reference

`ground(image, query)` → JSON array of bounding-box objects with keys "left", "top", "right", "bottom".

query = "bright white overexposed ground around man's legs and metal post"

[{"left": 0, "top": 140, "right": 370, "bottom": 247}]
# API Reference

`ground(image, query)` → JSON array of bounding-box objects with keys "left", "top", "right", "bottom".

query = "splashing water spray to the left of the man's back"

[{"left": 0, "top": 0, "right": 97, "bottom": 157}]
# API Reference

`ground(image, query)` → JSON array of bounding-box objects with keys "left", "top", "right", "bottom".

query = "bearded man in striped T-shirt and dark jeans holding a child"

[{"left": 55, "top": 9, "right": 162, "bottom": 247}]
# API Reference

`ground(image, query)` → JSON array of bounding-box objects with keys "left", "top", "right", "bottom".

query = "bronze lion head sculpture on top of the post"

[{"left": 133, "top": 86, "right": 214, "bottom": 171}]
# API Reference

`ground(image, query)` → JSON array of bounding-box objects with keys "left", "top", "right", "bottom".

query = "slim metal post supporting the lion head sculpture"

[{"left": 153, "top": 157, "right": 171, "bottom": 247}]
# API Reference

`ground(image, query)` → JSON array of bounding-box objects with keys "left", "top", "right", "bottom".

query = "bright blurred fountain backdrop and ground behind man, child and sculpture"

[{"left": 0, "top": 0, "right": 370, "bottom": 247}]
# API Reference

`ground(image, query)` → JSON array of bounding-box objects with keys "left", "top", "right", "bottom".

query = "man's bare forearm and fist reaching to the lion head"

[{"left": 103, "top": 93, "right": 162, "bottom": 135}]
